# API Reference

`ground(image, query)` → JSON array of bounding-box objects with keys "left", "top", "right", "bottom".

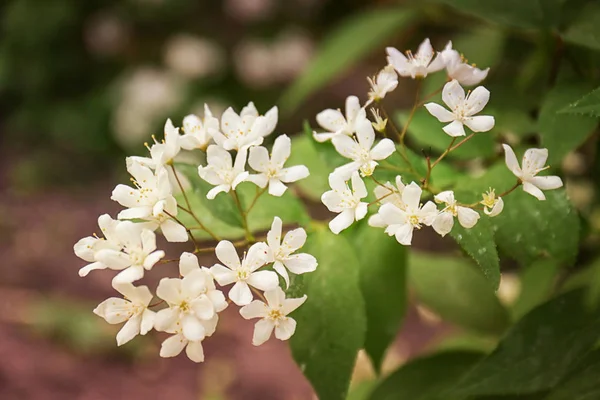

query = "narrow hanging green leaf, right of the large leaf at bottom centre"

[{"left": 353, "top": 223, "right": 407, "bottom": 372}]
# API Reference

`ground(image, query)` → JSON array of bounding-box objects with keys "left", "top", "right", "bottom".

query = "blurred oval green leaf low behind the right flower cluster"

[{"left": 408, "top": 252, "right": 509, "bottom": 335}]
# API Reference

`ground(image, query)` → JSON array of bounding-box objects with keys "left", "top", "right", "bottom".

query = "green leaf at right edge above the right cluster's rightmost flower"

[{"left": 538, "top": 83, "right": 598, "bottom": 165}]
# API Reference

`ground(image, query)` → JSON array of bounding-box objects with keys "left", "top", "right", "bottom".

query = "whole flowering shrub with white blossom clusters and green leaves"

[{"left": 75, "top": 10, "right": 595, "bottom": 399}]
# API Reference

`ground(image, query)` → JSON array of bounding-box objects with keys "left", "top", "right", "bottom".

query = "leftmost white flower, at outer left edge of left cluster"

[{"left": 73, "top": 214, "right": 122, "bottom": 277}]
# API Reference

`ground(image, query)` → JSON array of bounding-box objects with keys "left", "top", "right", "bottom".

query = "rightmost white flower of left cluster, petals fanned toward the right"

[{"left": 267, "top": 217, "right": 317, "bottom": 287}]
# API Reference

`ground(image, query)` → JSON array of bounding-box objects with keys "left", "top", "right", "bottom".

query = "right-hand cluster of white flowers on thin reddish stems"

[{"left": 313, "top": 39, "right": 562, "bottom": 245}]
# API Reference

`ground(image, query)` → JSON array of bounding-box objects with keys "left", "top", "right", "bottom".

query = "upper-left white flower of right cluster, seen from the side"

[{"left": 313, "top": 96, "right": 367, "bottom": 142}]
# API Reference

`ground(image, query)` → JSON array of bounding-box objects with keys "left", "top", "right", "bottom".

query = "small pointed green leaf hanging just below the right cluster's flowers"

[{"left": 450, "top": 214, "right": 500, "bottom": 290}]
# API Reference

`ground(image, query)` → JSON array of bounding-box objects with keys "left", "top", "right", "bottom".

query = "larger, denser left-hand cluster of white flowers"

[{"left": 74, "top": 103, "right": 314, "bottom": 362}]
